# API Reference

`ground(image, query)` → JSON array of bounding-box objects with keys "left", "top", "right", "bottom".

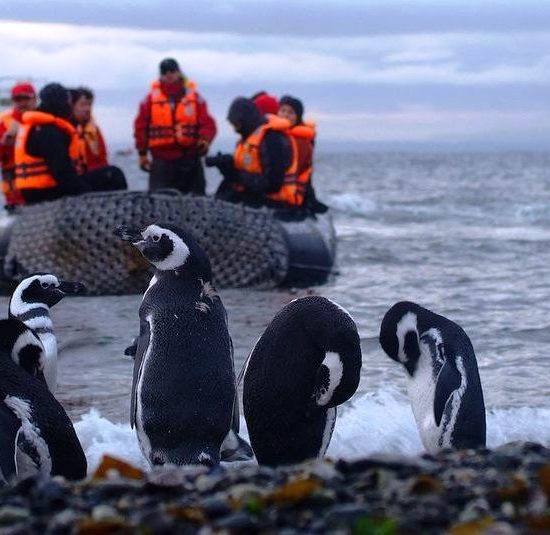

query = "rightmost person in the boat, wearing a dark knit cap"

[{"left": 278, "top": 95, "right": 327, "bottom": 212}]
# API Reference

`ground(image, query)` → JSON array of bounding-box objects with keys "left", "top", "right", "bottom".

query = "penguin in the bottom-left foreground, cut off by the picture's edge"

[{"left": 0, "top": 318, "right": 87, "bottom": 483}]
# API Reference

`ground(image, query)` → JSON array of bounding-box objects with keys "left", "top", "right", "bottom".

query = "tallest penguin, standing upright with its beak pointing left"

[{"left": 116, "top": 224, "right": 252, "bottom": 466}]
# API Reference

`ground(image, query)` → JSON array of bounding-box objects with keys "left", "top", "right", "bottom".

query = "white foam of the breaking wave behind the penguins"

[{"left": 75, "top": 387, "right": 550, "bottom": 472}]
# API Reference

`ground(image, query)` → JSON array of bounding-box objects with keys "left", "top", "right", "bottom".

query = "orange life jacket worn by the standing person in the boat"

[{"left": 147, "top": 80, "right": 199, "bottom": 148}]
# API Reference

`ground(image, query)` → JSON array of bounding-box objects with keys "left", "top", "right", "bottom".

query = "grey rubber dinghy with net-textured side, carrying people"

[{"left": 0, "top": 191, "right": 336, "bottom": 295}]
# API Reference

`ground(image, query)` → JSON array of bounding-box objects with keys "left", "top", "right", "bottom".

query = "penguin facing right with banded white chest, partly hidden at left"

[{"left": 9, "top": 273, "right": 85, "bottom": 392}]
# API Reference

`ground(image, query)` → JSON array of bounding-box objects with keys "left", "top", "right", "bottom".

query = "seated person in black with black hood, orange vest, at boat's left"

[{"left": 14, "top": 83, "right": 126, "bottom": 204}]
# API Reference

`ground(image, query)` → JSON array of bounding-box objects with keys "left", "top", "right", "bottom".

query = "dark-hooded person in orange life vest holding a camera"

[{"left": 211, "top": 97, "right": 293, "bottom": 207}]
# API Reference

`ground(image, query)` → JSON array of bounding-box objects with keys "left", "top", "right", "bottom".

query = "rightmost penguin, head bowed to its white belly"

[{"left": 379, "top": 301, "right": 486, "bottom": 453}]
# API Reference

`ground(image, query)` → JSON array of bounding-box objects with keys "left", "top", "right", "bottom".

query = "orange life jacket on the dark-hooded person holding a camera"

[{"left": 233, "top": 119, "right": 305, "bottom": 206}]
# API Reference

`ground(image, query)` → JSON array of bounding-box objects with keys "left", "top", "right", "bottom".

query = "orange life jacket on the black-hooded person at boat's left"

[{"left": 15, "top": 111, "right": 78, "bottom": 190}]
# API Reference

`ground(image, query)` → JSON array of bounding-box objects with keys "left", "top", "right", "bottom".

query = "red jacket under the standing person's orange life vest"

[{"left": 134, "top": 82, "right": 217, "bottom": 160}]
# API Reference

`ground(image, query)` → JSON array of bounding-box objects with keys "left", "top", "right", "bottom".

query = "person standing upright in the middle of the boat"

[{"left": 134, "top": 58, "right": 216, "bottom": 195}]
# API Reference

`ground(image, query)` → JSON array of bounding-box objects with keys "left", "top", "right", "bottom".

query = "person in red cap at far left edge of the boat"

[{"left": 0, "top": 82, "right": 36, "bottom": 211}]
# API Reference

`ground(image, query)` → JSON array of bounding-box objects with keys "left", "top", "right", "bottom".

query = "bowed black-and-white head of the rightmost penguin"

[{"left": 379, "top": 301, "right": 424, "bottom": 377}]
